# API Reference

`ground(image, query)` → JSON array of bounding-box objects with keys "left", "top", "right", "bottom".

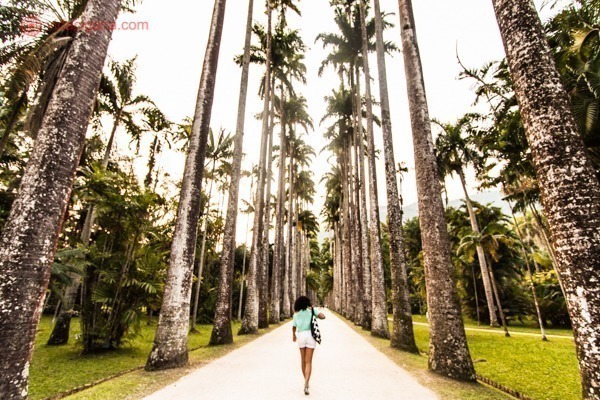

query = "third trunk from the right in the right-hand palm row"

[{"left": 374, "top": 0, "right": 419, "bottom": 354}]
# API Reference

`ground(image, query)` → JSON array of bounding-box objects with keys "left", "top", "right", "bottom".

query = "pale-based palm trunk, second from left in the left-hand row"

[{"left": 146, "top": 0, "right": 226, "bottom": 370}]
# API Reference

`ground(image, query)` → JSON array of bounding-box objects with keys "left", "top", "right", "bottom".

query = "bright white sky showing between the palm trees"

[{"left": 103, "top": 0, "right": 556, "bottom": 242}]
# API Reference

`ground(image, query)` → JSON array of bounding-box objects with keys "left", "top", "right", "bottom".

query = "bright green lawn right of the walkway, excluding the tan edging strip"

[{"left": 390, "top": 315, "right": 581, "bottom": 400}]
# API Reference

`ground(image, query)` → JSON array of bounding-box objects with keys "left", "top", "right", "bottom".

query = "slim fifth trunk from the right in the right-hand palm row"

[{"left": 355, "top": 64, "right": 373, "bottom": 330}]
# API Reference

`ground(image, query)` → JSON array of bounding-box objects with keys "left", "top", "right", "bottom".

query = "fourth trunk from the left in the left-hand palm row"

[{"left": 238, "top": 1, "right": 272, "bottom": 335}]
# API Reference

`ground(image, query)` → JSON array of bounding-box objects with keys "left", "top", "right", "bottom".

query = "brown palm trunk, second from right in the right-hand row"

[{"left": 398, "top": 0, "right": 475, "bottom": 381}]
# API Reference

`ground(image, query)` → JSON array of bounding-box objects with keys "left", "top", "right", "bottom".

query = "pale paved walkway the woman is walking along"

[{"left": 146, "top": 310, "right": 437, "bottom": 400}]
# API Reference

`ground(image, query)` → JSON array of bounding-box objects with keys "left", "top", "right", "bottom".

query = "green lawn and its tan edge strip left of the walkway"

[{"left": 29, "top": 317, "right": 262, "bottom": 400}]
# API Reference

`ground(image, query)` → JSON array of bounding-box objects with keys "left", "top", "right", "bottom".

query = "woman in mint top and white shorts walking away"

[{"left": 292, "top": 296, "right": 325, "bottom": 394}]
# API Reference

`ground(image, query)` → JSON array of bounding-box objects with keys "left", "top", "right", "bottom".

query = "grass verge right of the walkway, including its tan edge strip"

[{"left": 350, "top": 316, "right": 581, "bottom": 400}]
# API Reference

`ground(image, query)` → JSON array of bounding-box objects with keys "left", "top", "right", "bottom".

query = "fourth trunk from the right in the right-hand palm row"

[{"left": 360, "top": 0, "right": 390, "bottom": 338}]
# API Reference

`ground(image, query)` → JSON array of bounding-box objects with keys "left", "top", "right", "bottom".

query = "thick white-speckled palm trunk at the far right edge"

[{"left": 493, "top": 0, "right": 600, "bottom": 399}]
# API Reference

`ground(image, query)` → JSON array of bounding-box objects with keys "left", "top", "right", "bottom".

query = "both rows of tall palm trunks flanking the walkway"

[{"left": 0, "top": 0, "right": 600, "bottom": 399}]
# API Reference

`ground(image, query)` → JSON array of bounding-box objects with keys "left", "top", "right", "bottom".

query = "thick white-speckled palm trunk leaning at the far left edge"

[{"left": 0, "top": 0, "right": 120, "bottom": 399}]
